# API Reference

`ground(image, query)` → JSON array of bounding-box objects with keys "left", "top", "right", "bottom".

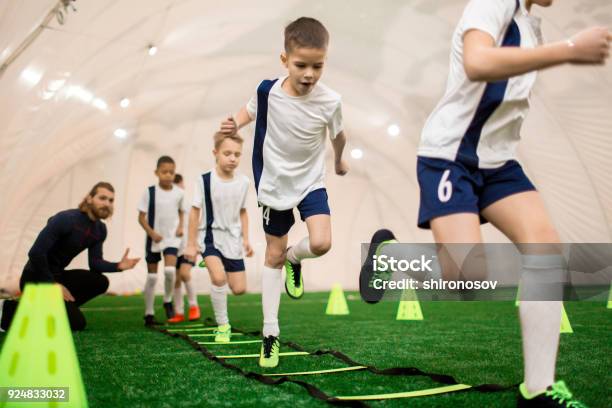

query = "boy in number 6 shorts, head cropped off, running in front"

[{"left": 360, "top": 0, "right": 611, "bottom": 407}]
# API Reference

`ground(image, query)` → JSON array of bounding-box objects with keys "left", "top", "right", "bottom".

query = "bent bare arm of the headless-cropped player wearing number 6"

[{"left": 463, "top": 27, "right": 612, "bottom": 82}]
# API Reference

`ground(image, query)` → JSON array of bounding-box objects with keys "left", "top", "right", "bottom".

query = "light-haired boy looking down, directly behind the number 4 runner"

[{"left": 185, "top": 132, "right": 253, "bottom": 343}]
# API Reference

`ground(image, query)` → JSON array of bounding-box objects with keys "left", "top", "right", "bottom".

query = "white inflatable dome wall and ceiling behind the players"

[{"left": 0, "top": 0, "right": 612, "bottom": 293}]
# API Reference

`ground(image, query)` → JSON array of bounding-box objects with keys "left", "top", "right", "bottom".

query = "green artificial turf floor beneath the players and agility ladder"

[{"left": 0, "top": 293, "right": 612, "bottom": 408}]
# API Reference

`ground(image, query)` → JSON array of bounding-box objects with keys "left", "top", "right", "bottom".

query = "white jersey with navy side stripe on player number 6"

[{"left": 418, "top": 0, "right": 542, "bottom": 168}]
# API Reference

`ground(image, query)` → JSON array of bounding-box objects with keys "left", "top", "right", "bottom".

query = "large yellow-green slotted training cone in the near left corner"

[{"left": 0, "top": 284, "right": 88, "bottom": 408}]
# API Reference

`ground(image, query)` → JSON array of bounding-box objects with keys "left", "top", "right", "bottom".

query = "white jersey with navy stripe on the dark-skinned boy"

[{"left": 138, "top": 185, "right": 184, "bottom": 252}]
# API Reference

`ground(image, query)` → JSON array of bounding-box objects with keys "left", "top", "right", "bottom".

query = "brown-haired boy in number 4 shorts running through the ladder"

[{"left": 221, "top": 17, "right": 348, "bottom": 367}]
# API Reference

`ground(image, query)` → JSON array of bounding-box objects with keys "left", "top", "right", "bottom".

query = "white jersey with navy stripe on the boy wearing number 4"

[{"left": 247, "top": 77, "right": 342, "bottom": 211}]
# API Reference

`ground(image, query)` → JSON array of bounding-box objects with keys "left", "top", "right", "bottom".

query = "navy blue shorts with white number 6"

[{"left": 417, "top": 156, "right": 535, "bottom": 229}]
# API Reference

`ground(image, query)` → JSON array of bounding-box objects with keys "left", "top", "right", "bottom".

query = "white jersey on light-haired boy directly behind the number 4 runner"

[{"left": 192, "top": 169, "right": 249, "bottom": 259}]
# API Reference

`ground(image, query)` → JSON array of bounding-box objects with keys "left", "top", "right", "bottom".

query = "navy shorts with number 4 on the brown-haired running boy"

[{"left": 263, "top": 188, "right": 330, "bottom": 237}]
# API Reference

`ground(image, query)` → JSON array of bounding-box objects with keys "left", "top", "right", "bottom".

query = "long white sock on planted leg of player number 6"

[{"left": 519, "top": 255, "right": 567, "bottom": 393}]
